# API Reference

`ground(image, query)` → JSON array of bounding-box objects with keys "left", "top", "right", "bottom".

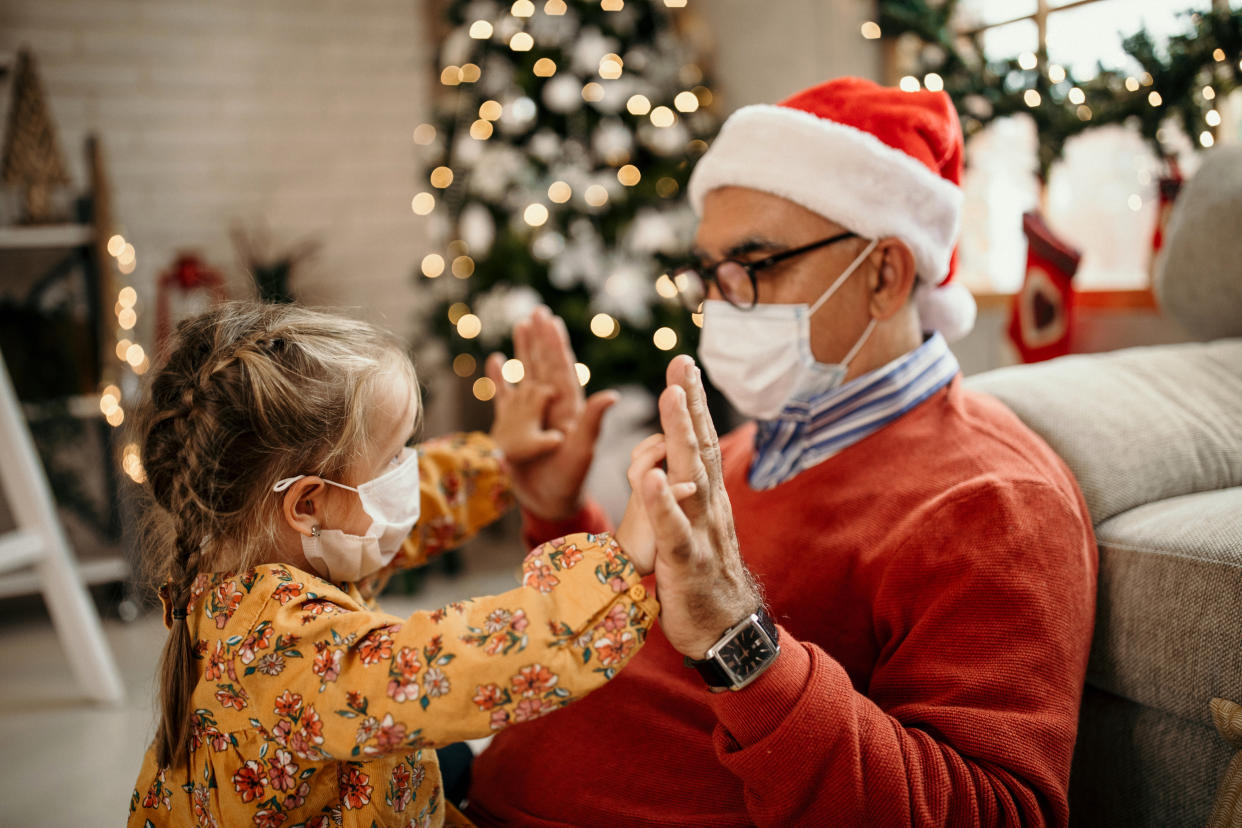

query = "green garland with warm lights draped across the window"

[{"left": 879, "top": 0, "right": 1242, "bottom": 179}]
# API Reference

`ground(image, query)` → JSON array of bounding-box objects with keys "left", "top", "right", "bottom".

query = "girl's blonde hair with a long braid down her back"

[{"left": 135, "top": 302, "right": 417, "bottom": 767}]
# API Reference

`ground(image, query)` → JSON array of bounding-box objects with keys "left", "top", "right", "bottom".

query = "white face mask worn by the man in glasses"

[{"left": 698, "top": 240, "right": 878, "bottom": 420}]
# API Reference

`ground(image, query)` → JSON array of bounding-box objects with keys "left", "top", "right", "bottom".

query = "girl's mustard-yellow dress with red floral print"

[{"left": 129, "top": 434, "right": 660, "bottom": 828}]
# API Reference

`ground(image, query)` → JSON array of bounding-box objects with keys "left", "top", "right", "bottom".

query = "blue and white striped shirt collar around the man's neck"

[{"left": 749, "top": 334, "right": 959, "bottom": 489}]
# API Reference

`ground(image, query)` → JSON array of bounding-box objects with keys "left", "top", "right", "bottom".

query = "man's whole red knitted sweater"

[{"left": 468, "top": 377, "right": 1095, "bottom": 827}]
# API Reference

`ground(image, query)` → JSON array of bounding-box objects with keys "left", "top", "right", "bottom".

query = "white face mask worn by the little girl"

[{"left": 272, "top": 448, "right": 421, "bottom": 582}]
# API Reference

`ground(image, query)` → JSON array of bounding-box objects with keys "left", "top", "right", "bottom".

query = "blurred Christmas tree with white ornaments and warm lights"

[{"left": 412, "top": 0, "right": 718, "bottom": 400}]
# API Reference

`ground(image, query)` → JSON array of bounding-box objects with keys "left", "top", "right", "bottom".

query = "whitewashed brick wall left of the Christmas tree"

[{"left": 0, "top": 0, "right": 435, "bottom": 341}]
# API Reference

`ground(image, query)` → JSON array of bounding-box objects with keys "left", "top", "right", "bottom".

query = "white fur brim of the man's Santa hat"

[{"left": 689, "top": 104, "right": 961, "bottom": 284}]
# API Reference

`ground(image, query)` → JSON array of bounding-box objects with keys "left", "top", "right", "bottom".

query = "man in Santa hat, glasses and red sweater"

[{"left": 469, "top": 78, "right": 1095, "bottom": 826}]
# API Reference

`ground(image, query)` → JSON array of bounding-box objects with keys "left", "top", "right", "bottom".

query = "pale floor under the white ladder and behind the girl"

[{"left": 0, "top": 534, "right": 523, "bottom": 828}]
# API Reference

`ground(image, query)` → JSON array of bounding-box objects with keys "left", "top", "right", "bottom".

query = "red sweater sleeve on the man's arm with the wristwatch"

[{"left": 710, "top": 483, "right": 1095, "bottom": 826}]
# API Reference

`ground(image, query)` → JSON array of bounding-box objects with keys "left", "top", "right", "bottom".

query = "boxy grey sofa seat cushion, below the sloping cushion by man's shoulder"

[{"left": 1087, "top": 488, "right": 1242, "bottom": 726}]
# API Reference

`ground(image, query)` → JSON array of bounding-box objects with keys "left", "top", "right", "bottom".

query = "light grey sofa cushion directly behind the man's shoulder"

[{"left": 968, "top": 339, "right": 1242, "bottom": 525}]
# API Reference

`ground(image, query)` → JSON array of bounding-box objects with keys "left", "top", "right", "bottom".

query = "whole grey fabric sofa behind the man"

[{"left": 968, "top": 146, "right": 1242, "bottom": 828}]
